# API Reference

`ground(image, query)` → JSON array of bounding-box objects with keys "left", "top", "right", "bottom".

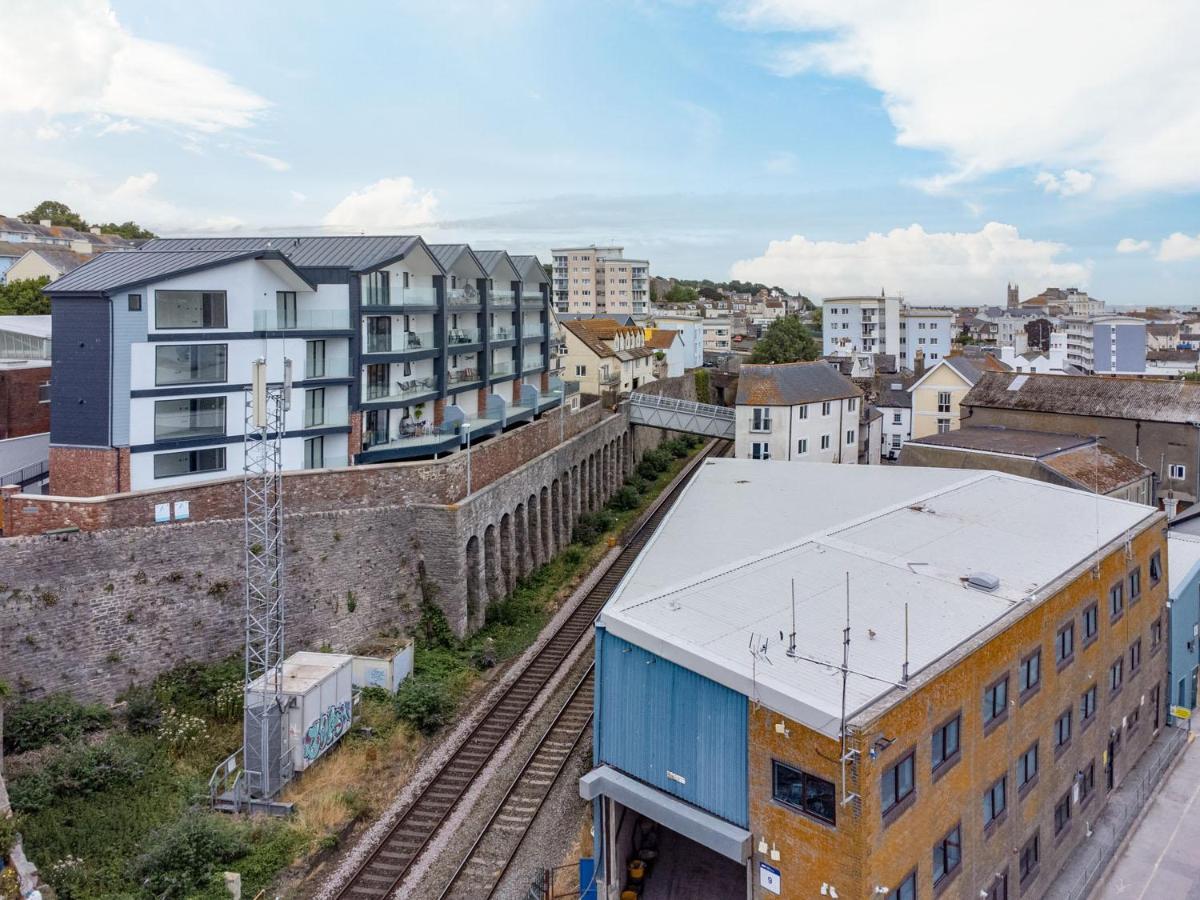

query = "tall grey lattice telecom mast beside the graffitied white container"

[{"left": 242, "top": 359, "right": 293, "bottom": 805}]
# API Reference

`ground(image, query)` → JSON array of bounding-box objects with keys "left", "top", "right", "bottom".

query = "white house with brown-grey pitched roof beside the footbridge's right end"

[{"left": 734, "top": 361, "right": 863, "bottom": 463}]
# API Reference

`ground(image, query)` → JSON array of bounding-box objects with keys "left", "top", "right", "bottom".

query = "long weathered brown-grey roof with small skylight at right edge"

[{"left": 962, "top": 372, "right": 1200, "bottom": 424}]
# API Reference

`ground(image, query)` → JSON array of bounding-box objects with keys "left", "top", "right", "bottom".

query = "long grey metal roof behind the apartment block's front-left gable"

[{"left": 142, "top": 234, "right": 421, "bottom": 271}]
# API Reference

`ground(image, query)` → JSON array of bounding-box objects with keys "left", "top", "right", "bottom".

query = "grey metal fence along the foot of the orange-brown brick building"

[{"left": 1044, "top": 728, "right": 1188, "bottom": 900}]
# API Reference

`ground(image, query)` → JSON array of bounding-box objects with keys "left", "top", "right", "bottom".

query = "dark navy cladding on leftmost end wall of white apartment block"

[{"left": 50, "top": 296, "right": 112, "bottom": 446}]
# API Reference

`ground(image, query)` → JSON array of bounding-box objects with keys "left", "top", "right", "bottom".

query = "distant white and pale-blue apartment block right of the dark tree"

[{"left": 822, "top": 294, "right": 954, "bottom": 370}]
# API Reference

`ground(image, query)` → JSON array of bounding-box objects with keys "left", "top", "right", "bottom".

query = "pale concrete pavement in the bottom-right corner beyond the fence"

[{"left": 1093, "top": 736, "right": 1200, "bottom": 900}]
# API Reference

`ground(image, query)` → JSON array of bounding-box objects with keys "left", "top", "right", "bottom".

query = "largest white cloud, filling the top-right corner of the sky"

[{"left": 727, "top": 0, "right": 1200, "bottom": 193}]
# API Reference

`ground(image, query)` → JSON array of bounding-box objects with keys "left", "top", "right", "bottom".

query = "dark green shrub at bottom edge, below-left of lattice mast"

[{"left": 131, "top": 812, "right": 250, "bottom": 898}]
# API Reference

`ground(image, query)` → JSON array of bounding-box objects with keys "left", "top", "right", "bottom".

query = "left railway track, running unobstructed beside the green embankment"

[{"left": 335, "top": 440, "right": 731, "bottom": 900}]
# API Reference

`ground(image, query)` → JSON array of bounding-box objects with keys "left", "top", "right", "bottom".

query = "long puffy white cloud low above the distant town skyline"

[{"left": 731, "top": 222, "right": 1091, "bottom": 304}]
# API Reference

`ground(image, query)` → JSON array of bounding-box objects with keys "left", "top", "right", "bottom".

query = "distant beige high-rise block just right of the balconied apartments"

[{"left": 551, "top": 245, "right": 650, "bottom": 316}]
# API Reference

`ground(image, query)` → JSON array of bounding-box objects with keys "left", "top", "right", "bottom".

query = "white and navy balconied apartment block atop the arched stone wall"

[{"left": 46, "top": 236, "right": 562, "bottom": 496}]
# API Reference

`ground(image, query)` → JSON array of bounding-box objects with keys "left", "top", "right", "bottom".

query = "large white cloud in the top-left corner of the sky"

[{"left": 0, "top": 0, "right": 268, "bottom": 132}]
